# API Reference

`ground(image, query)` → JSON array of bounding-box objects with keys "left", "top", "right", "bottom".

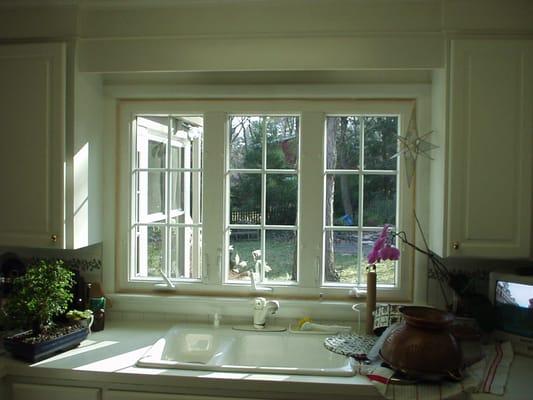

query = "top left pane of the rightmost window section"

[{"left": 326, "top": 116, "right": 361, "bottom": 169}]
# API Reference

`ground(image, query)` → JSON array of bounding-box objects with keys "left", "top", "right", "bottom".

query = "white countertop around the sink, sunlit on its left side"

[{"left": 0, "top": 321, "right": 533, "bottom": 400}]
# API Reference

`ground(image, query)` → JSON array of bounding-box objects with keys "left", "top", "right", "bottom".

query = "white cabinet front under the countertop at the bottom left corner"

[{"left": 12, "top": 383, "right": 100, "bottom": 400}]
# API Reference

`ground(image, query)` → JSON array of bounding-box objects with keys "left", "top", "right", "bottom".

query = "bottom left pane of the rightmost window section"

[{"left": 324, "top": 230, "right": 359, "bottom": 284}]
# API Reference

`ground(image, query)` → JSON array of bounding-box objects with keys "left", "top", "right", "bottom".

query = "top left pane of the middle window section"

[{"left": 229, "top": 116, "right": 266, "bottom": 169}]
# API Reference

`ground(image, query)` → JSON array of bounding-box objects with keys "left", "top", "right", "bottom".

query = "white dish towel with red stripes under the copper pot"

[{"left": 358, "top": 342, "right": 513, "bottom": 400}]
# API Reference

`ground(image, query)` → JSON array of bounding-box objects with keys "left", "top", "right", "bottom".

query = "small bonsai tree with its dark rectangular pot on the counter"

[{"left": 4, "top": 260, "right": 89, "bottom": 362}]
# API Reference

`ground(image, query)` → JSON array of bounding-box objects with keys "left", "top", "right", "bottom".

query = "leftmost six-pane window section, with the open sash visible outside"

[{"left": 130, "top": 115, "right": 203, "bottom": 280}]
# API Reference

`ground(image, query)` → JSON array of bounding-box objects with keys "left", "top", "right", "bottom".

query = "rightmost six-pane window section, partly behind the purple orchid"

[{"left": 324, "top": 115, "right": 400, "bottom": 286}]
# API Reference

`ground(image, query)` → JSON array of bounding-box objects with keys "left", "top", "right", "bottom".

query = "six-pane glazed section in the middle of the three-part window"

[{"left": 226, "top": 115, "right": 299, "bottom": 283}]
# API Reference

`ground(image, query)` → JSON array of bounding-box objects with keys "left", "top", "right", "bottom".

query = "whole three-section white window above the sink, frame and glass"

[{"left": 116, "top": 100, "right": 413, "bottom": 299}]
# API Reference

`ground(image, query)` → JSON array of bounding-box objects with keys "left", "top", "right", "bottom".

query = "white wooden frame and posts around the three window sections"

[{"left": 115, "top": 98, "right": 415, "bottom": 301}]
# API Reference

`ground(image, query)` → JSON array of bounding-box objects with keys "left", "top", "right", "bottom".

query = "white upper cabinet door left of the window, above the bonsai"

[{"left": 0, "top": 43, "right": 65, "bottom": 247}]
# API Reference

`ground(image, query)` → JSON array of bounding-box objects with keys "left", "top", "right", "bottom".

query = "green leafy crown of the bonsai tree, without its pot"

[{"left": 6, "top": 260, "right": 74, "bottom": 336}]
